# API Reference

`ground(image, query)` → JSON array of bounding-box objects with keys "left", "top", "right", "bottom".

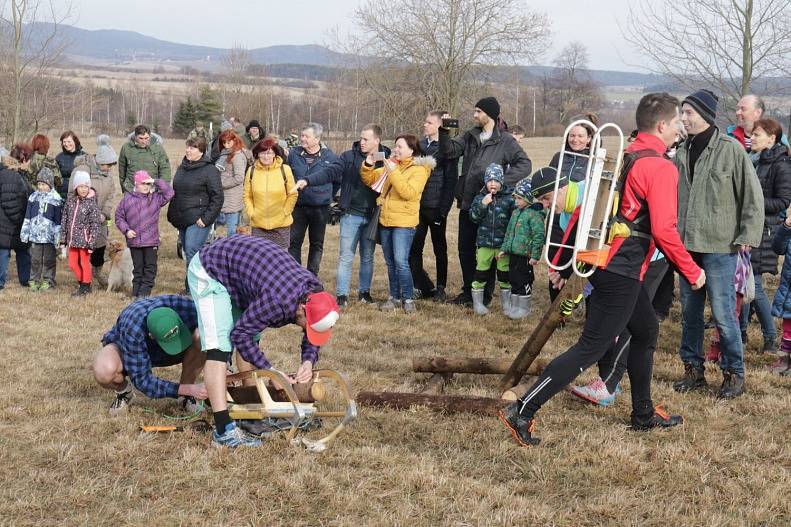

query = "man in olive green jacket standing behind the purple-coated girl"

[{"left": 118, "top": 124, "right": 170, "bottom": 194}]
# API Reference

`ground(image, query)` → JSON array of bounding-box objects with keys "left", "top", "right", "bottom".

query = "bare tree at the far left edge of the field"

[{"left": 0, "top": 0, "right": 71, "bottom": 142}]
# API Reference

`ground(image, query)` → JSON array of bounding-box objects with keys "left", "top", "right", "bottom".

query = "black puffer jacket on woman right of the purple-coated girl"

[{"left": 168, "top": 157, "right": 223, "bottom": 229}]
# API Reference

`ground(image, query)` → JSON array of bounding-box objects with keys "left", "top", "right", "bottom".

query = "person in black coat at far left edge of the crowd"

[{"left": 0, "top": 144, "right": 33, "bottom": 289}]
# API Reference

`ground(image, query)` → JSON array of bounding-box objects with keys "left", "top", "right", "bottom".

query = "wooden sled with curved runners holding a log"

[{"left": 226, "top": 370, "right": 357, "bottom": 452}]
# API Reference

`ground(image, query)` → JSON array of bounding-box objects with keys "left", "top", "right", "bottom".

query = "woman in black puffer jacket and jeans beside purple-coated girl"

[{"left": 168, "top": 137, "right": 224, "bottom": 289}]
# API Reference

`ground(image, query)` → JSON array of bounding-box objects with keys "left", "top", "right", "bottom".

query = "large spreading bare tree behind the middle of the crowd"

[{"left": 352, "top": 0, "right": 549, "bottom": 112}]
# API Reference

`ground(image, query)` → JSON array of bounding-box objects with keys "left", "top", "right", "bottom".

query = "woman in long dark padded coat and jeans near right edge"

[{"left": 740, "top": 119, "right": 791, "bottom": 353}]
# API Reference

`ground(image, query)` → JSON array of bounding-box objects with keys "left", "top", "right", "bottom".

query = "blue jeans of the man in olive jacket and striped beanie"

[{"left": 679, "top": 253, "right": 744, "bottom": 377}]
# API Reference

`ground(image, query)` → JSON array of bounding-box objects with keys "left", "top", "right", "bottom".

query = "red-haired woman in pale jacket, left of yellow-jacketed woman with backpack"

[{"left": 214, "top": 130, "right": 247, "bottom": 236}]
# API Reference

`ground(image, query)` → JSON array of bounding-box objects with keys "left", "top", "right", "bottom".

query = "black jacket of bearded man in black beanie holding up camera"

[{"left": 439, "top": 127, "right": 533, "bottom": 210}]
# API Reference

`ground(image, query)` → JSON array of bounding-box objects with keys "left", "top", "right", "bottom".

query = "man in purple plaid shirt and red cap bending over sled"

[{"left": 192, "top": 234, "right": 340, "bottom": 447}]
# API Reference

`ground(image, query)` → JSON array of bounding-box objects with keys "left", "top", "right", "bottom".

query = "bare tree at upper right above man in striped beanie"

[{"left": 621, "top": 0, "right": 791, "bottom": 102}]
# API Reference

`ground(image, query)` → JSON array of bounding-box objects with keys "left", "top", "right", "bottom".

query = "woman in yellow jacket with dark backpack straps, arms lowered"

[{"left": 244, "top": 138, "right": 298, "bottom": 250}]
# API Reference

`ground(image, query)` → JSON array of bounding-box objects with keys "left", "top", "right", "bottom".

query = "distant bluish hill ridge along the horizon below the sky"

[{"left": 31, "top": 23, "right": 667, "bottom": 86}]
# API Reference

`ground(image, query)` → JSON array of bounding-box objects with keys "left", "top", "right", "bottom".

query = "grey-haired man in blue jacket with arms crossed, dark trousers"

[{"left": 287, "top": 123, "right": 340, "bottom": 276}]
